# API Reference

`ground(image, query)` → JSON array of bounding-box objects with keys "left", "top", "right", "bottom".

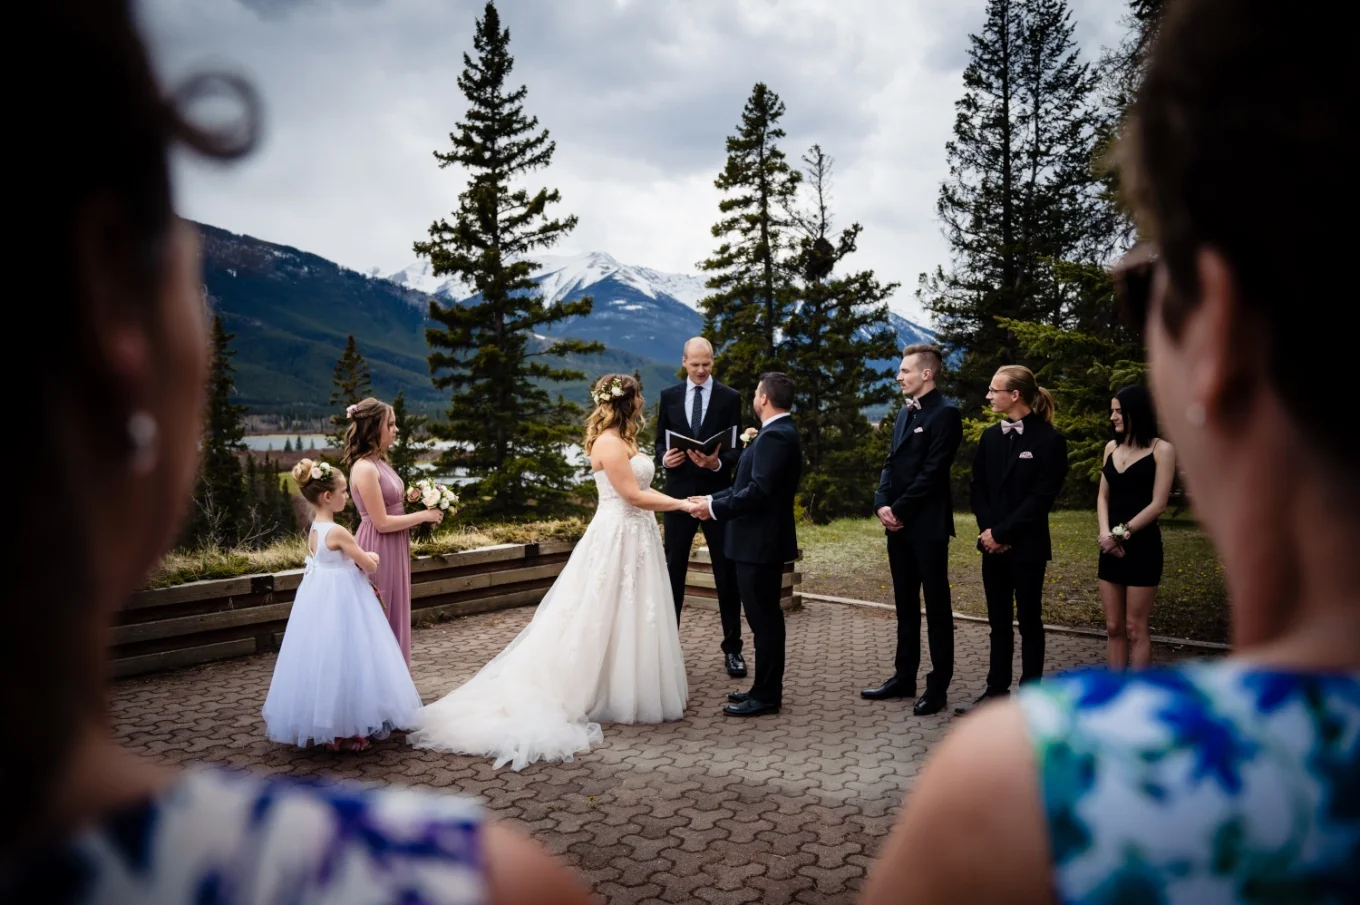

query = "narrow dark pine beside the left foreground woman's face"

[{"left": 188, "top": 314, "right": 246, "bottom": 548}]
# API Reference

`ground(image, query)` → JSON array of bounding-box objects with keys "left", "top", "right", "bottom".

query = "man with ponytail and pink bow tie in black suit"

[{"left": 955, "top": 365, "right": 1068, "bottom": 713}]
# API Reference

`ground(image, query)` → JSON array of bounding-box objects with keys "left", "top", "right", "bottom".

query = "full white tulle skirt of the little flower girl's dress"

[{"left": 264, "top": 561, "right": 420, "bottom": 746}]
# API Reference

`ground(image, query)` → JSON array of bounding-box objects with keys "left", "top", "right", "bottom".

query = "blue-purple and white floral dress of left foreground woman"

[{"left": 13, "top": 769, "right": 486, "bottom": 905}]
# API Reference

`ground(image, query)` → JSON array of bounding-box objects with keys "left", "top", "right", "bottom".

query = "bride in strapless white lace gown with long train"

[{"left": 407, "top": 374, "right": 694, "bottom": 770}]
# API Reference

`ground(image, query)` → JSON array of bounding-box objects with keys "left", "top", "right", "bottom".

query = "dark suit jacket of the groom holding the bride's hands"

[{"left": 713, "top": 416, "right": 802, "bottom": 565}]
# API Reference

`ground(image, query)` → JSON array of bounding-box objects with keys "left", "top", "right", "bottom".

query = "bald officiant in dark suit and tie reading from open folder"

[{"left": 656, "top": 336, "right": 747, "bottom": 679}]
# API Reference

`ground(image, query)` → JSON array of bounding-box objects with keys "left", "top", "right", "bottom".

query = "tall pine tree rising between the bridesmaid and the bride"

[{"left": 415, "top": 3, "right": 604, "bottom": 519}]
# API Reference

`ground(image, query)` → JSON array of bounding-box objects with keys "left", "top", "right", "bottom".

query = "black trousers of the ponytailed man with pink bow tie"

[{"left": 982, "top": 553, "right": 1049, "bottom": 693}]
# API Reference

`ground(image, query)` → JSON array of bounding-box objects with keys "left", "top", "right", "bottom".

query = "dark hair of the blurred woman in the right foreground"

[{"left": 1119, "top": 0, "right": 1360, "bottom": 461}]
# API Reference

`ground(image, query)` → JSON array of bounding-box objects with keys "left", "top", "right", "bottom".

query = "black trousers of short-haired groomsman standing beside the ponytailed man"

[{"left": 888, "top": 531, "right": 953, "bottom": 694}]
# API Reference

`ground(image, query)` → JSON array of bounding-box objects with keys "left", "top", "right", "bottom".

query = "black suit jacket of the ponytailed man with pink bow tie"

[{"left": 972, "top": 412, "right": 1068, "bottom": 562}]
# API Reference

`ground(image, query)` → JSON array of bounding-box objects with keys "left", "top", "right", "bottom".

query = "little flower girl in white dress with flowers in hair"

[{"left": 264, "top": 459, "right": 420, "bottom": 751}]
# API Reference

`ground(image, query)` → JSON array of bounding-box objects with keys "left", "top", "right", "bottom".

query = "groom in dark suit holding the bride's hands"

[{"left": 695, "top": 373, "right": 802, "bottom": 716}]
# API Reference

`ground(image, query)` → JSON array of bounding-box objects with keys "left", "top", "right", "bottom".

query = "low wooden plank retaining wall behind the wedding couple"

[{"left": 112, "top": 542, "right": 801, "bottom": 676}]
